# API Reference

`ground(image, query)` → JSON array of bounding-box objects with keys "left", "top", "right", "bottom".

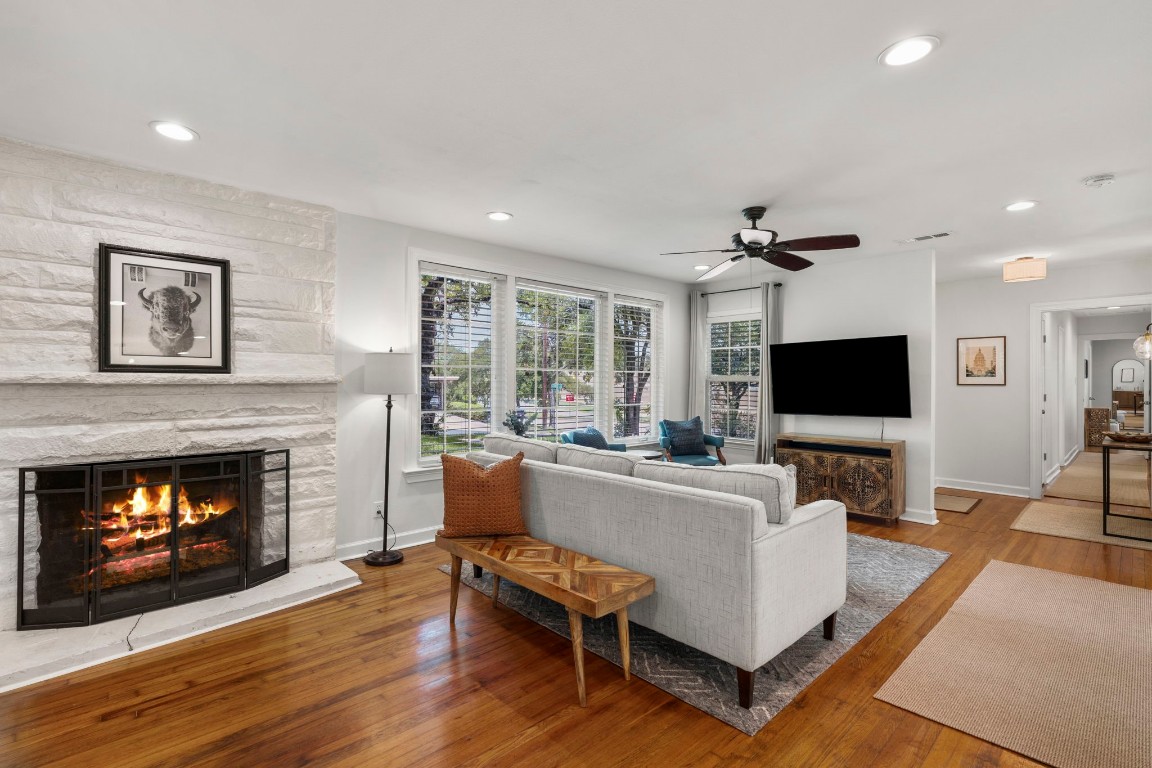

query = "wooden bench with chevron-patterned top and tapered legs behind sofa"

[{"left": 435, "top": 535, "right": 655, "bottom": 707}]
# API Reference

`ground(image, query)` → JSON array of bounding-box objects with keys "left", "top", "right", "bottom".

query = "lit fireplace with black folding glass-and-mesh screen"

[{"left": 16, "top": 450, "right": 289, "bottom": 630}]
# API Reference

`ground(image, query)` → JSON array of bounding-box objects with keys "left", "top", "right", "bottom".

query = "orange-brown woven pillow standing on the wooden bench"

[{"left": 439, "top": 453, "right": 528, "bottom": 539}]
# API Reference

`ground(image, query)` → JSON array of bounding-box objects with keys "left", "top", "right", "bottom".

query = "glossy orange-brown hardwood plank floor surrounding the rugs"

[{"left": 0, "top": 491, "right": 1152, "bottom": 768}]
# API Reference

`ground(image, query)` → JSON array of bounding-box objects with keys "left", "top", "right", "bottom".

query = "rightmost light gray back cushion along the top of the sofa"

[{"left": 634, "top": 462, "right": 793, "bottom": 525}]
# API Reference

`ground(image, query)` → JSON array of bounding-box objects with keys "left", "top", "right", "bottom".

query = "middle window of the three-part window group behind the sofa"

[{"left": 514, "top": 287, "right": 597, "bottom": 441}]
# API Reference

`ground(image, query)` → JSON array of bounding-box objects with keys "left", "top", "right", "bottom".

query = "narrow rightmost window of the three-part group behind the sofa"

[{"left": 612, "top": 299, "right": 662, "bottom": 438}]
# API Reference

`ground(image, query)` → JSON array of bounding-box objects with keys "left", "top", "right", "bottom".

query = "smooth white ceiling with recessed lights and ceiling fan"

[{"left": 0, "top": 0, "right": 1152, "bottom": 281}]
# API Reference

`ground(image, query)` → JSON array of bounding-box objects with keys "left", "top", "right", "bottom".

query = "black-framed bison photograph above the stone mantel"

[{"left": 99, "top": 243, "right": 232, "bottom": 373}]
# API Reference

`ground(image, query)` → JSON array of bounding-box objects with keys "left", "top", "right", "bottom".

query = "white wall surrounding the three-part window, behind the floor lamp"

[{"left": 336, "top": 214, "right": 689, "bottom": 558}]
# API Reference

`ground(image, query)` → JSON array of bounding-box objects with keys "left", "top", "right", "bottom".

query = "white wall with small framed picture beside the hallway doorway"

[{"left": 935, "top": 257, "right": 1152, "bottom": 496}]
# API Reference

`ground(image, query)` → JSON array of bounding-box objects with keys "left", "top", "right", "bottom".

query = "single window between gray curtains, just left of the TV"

[{"left": 707, "top": 320, "right": 760, "bottom": 440}]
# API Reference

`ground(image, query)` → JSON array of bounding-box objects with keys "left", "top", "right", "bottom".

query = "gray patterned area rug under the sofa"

[{"left": 440, "top": 533, "right": 948, "bottom": 736}]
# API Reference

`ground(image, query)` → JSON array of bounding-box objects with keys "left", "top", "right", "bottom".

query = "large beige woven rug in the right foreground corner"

[{"left": 876, "top": 561, "right": 1152, "bottom": 768}]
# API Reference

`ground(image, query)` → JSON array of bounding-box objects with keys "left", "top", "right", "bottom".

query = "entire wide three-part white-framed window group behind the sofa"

[{"left": 414, "top": 260, "right": 664, "bottom": 466}]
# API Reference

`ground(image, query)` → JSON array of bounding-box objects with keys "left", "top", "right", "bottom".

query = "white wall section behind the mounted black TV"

[{"left": 712, "top": 251, "right": 935, "bottom": 523}]
